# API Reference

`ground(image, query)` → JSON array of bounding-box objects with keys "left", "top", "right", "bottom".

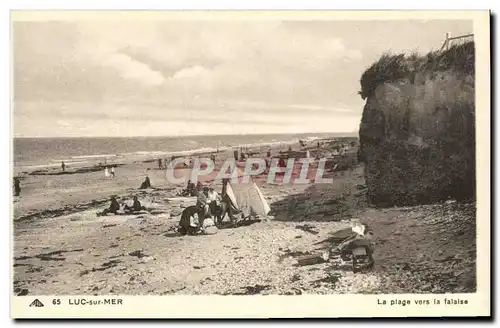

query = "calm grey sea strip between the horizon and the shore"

[{"left": 13, "top": 133, "right": 355, "bottom": 169}]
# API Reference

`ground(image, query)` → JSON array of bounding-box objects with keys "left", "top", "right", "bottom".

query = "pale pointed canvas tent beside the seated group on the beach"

[{"left": 225, "top": 168, "right": 271, "bottom": 217}]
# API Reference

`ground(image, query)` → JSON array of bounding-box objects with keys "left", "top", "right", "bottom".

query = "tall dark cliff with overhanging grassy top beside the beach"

[{"left": 359, "top": 42, "right": 475, "bottom": 206}]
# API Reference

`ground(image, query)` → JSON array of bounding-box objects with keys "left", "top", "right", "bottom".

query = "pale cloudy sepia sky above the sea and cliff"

[{"left": 12, "top": 19, "right": 473, "bottom": 137}]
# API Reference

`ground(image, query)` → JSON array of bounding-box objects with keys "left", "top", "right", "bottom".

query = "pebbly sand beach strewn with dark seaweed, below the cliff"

[{"left": 13, "top": 139, "right": 476, "bottom": 295}]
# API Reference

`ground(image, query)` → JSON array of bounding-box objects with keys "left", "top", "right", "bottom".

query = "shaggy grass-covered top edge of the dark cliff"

[{"left": 359, "top": 41, "right": 475, "bottom": 99}]
